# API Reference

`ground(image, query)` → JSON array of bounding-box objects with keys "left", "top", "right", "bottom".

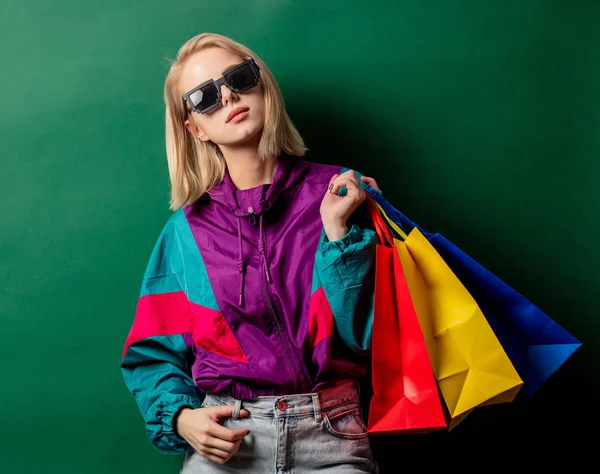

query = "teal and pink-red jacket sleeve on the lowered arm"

[{"left": 120, "top": 216, "right": 203, "bottom": 454}]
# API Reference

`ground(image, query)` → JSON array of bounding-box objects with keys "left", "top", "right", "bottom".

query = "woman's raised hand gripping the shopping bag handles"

[{"left": 320, "top": 170, "right": 381, "bottom": 241}]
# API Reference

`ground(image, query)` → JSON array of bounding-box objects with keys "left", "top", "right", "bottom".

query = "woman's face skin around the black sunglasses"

[{"left": 179, "top": 48, "right": 265, "bottom": 147}]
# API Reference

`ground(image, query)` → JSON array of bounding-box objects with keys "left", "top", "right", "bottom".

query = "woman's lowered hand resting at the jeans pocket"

[{"left": 175, "top": 405, "right": 250, "bottom": 464}]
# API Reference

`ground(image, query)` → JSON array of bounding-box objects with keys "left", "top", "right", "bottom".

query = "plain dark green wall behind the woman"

[{"left": 0, "top": 0, "right": 600, "bottom": 474}]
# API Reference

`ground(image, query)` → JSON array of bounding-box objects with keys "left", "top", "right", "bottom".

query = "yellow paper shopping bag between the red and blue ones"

[{"left": 392, "top": 226, "right": 523, "bottom": 429}]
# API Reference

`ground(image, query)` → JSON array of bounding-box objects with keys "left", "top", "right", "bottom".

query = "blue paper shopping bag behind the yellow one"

[{"left": 366, "top": 188, "right": 581, "bottom": 396}]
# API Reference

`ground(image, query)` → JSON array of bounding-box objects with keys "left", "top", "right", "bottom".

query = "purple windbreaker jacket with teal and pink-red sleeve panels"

[{"left": 120, "top": 153, "right": 378, "bottom": 454}]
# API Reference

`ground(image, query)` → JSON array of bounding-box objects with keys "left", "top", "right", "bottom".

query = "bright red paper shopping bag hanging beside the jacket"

[{"left": 368, "top": 195, "right": 447, "bottom": 435}]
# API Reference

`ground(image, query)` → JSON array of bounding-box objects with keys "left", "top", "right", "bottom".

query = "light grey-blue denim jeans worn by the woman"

[{"left": 180, "top": 380, "right": 379, "bottom": 474}]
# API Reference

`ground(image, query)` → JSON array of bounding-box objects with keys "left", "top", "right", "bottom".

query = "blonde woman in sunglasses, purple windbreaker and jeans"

[{"left": 121, "top": 33, "right": 378, "bottom": 474}]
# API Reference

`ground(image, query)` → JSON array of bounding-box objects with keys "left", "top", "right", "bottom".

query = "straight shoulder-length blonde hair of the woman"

[{"left": 164, "top": 33, "right": 308, "bottom": 211}]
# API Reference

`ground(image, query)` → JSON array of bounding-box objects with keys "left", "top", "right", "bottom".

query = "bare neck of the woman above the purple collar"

[{"left": 221, "top": 141, "right": 277, "bottom": 190}]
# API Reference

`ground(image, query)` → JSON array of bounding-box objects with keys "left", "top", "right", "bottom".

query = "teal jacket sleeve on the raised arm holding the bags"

[{"left": 315, "top": 168, "right": 379, "bottom": 356}]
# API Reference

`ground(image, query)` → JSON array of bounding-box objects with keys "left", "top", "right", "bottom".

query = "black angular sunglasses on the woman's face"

[{"left": 183, "top": 58, "right": 260, "bottom": 114}]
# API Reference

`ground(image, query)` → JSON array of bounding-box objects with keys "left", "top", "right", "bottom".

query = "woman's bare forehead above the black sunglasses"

[{"left": 180, "top": 48, "right": 243, "bottom": 93}]
